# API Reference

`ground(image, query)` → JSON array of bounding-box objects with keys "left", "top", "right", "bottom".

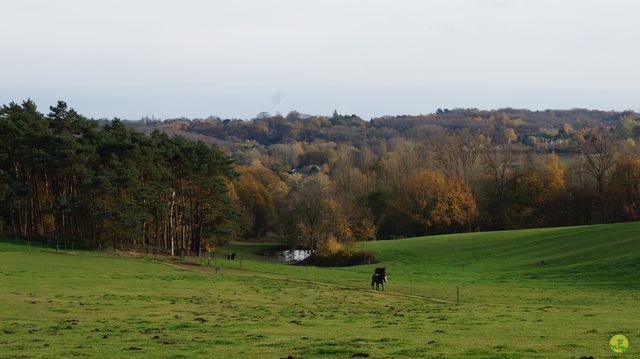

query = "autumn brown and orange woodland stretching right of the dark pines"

[{"left": 127, "top": 108, "right": 640, "bottom": 242}]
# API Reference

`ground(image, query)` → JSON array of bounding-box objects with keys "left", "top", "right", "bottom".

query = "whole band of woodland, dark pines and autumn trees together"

[{"left": 0, "top": 100, "right": 640, "bottom": 254}]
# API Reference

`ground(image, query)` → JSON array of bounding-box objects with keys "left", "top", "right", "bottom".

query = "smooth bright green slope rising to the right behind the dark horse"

[{"left": 369, "top": 223, "right": 640, "bottom": 289}]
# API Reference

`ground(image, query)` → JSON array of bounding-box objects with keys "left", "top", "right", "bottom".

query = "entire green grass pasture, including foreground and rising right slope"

[{"left": 0, "top": 223, "right": 640, "bottom": 358}]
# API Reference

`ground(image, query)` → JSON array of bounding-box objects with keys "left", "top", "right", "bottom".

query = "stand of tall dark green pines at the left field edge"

[{"left": 0, "top": 100, "right": 239, "bottom": 254}]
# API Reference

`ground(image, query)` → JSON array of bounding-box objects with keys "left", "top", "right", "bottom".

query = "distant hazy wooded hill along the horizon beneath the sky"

[{"left": 122, "top": 108, "right": 640, "bottom": 149}]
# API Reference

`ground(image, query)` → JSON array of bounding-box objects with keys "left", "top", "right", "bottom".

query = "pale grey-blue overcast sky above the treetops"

[{"left": 0, "top": 0, "right": 640, "bottom": 120}]
